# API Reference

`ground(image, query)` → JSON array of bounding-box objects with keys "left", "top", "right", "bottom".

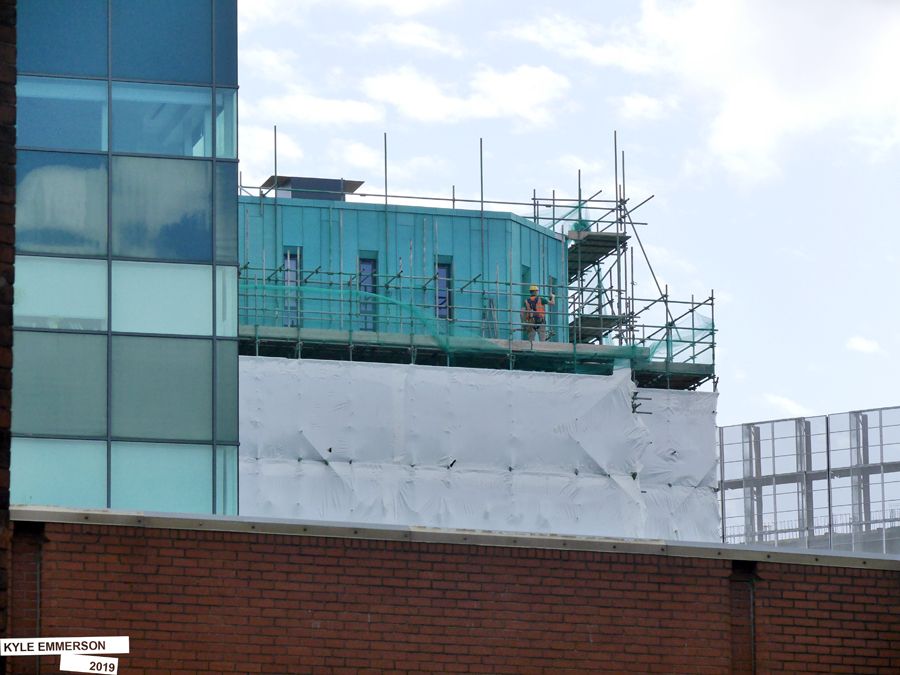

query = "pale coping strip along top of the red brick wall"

[{"left": 10, "top": 506, "right": 900, "bottom": 571}]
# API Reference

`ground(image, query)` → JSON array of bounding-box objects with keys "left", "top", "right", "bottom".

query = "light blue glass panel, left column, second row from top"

[{"left": 16, "top": 77, "right": 108, "bottom": 150}]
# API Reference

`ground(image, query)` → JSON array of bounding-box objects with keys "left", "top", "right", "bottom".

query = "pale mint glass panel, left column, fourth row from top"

[{"left": 13, "top": 255, "right": 107, "bottom": 331}]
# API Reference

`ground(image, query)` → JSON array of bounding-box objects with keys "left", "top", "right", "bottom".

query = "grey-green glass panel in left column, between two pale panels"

[{"left": 12, "top": 330, "right": 106, "bottom": 436}]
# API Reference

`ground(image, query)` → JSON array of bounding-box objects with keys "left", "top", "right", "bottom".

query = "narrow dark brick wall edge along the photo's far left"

[{"left": 0, "top": 0, "right": 16, "bottom": 669}]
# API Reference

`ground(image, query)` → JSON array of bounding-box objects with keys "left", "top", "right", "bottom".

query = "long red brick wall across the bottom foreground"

[{"left": 10, "top": 523, "right": 900, "bottom": 673}]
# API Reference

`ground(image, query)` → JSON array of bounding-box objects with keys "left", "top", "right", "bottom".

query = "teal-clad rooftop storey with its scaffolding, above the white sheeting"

[{"left": 239, "top": 161, "right": 715, "bottom": 389}]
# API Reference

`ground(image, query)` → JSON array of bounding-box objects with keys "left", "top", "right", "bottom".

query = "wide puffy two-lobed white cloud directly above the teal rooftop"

[{"left": 363, "top": 66, "right": 569, "bottom": 127}]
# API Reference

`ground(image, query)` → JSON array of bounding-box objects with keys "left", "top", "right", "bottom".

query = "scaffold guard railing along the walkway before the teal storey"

[{"left": 238, "top": 266, "right": 715, "bottom": 364}]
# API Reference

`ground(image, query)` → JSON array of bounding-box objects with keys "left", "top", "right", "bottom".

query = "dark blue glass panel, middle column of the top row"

[{"left": 112, "top": 0, "right": 212, "bottom": 84}]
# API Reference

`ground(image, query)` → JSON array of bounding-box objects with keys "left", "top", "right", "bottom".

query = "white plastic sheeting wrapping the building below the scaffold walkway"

[{"left": 240, "top": 357, "right": 718, "bottom": 539}]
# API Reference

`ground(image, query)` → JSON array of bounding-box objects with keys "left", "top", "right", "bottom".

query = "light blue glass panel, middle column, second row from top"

[{"left": 112, "top": 82, "right": 218, "bottom": 157}]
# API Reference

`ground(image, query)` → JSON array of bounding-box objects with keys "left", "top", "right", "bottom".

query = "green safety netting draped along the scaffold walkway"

[{"left": 239, "top": 279, "right": 714, "bottom": 374}]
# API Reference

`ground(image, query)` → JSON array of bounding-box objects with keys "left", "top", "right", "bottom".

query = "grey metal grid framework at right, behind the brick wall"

[{"left": 718, "top": 407, "right": 900, "bottom": 555}]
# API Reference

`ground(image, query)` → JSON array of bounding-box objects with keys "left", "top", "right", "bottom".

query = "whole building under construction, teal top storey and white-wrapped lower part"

[{"left": 236, "top": 164, "right": 718, "bottom": 541}]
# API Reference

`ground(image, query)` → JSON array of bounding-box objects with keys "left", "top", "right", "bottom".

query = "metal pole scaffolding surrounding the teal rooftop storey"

[{"left": 239, "top": 131, "right": 716, "bottom": 389}]
